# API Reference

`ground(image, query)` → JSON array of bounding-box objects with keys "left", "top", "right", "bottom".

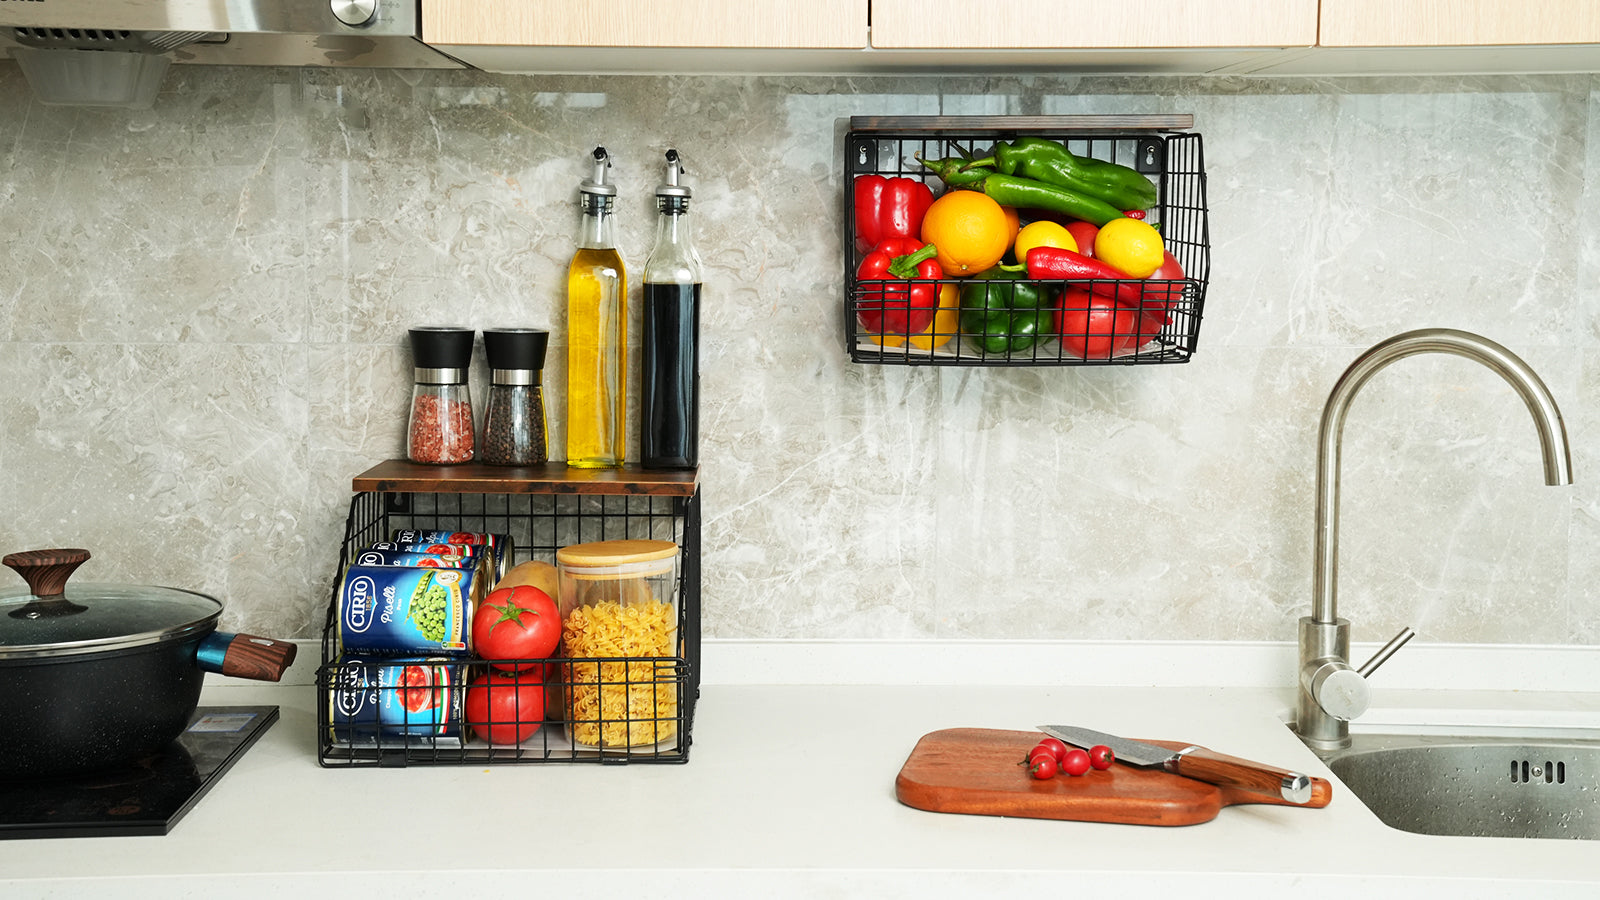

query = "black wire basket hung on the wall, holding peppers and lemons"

[{"left": 843, "top": 114, "right": 1211, "bottom": 367}]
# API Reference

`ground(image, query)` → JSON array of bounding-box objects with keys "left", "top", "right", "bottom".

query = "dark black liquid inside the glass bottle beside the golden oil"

[{"left": 638, "top": 282, "right": 701, "bottom": 469}]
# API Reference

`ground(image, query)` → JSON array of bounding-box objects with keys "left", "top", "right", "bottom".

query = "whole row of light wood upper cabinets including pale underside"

[{"left": 421, "top": 0, "right": 1600, "bottom": 75}]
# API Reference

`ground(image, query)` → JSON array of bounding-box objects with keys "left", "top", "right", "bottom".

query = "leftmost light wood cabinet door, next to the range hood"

[{"left": 422, "top": 0, "right": 867, "bottom": 50}]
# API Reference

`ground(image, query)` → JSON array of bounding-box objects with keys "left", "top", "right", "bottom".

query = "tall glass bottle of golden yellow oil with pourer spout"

[{"left": 566, "top": 147, "right": 627, "bottom": 469}]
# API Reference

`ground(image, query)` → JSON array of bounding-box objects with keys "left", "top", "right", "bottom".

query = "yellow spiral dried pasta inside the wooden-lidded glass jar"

[{"left": 562, "top": 601, "right": 678, "bottom": 748}]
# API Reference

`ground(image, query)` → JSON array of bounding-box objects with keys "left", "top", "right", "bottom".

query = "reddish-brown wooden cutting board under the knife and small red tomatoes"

[{"left": 894, "top": 729, "right": 1331, "bottom": 825}]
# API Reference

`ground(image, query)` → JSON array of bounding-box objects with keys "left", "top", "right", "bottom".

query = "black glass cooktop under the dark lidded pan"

[{"left": 0, "top": 706, "right": 278, "bottom": 839}]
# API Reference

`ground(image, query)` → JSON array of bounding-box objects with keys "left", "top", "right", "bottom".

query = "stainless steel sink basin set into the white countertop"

[{"left": 1325, "top": 733, "right": 1600, "bottom": 841}]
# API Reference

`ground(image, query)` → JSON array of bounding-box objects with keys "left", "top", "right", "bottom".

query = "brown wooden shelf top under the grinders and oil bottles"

[{"left": 350, "top": 460, "right": 699, "bottom": 496}]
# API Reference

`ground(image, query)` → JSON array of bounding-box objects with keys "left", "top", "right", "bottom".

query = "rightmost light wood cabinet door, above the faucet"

[{"left": 1318, "top": 0, "right": 1600, "bottom": 46}]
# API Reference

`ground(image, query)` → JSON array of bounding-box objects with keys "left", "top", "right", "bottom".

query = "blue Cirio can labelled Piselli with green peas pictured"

[{"left": 339, "top": 565, "right": 483, "bottom": 657}]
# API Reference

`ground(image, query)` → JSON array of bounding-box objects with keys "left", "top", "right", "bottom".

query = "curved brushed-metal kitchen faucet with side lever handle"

[{"left": 1294, "top": 328, "right": 1573, "bottom": 751}]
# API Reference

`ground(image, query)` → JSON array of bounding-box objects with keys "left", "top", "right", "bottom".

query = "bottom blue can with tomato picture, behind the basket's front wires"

[{"left": 328, "top": 657, "right": 467, "bottom": 743}]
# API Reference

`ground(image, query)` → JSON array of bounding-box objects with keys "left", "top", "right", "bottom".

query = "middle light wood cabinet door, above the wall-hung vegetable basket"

[{"left": 872, "top": 0, "right": 1317, "bottom": 50}]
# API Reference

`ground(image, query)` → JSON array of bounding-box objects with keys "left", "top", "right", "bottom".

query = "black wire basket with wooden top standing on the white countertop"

[{"left": 317, "top": 460, "right": 701, "bottom": 767}]
